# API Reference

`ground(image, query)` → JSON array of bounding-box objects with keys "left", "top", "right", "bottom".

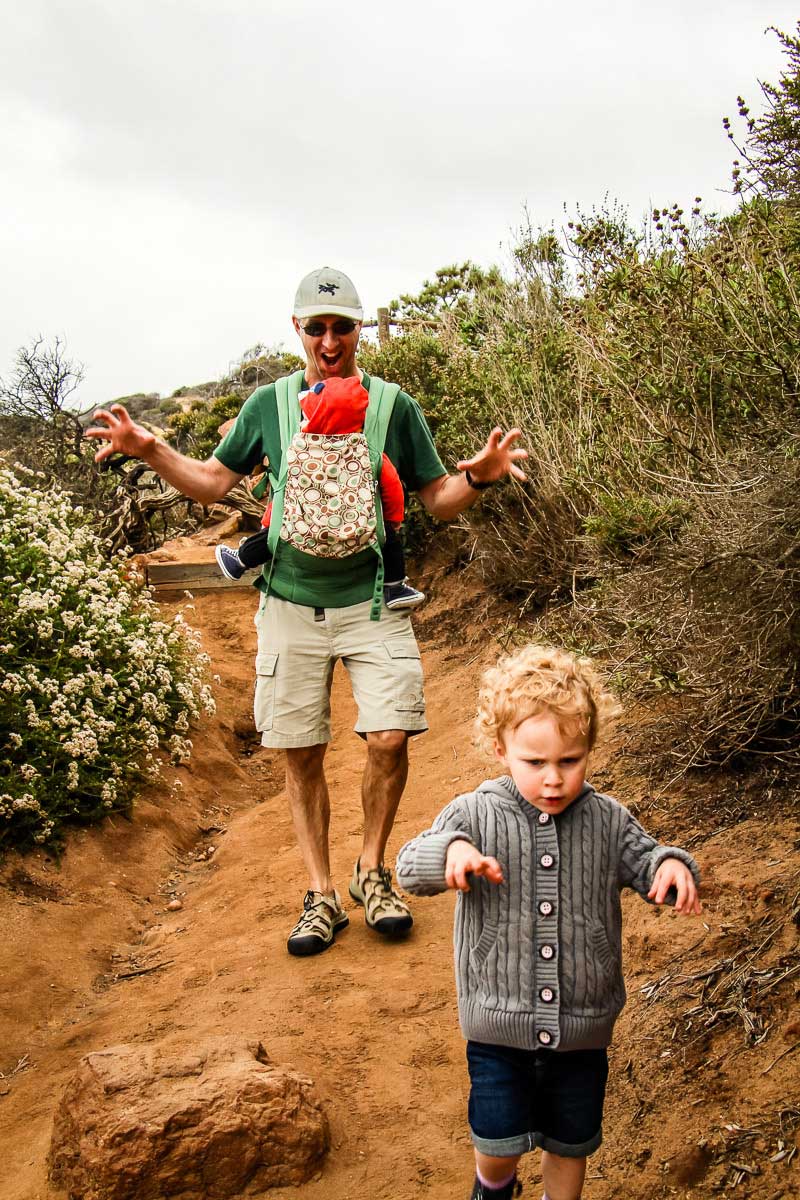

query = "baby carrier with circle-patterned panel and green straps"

[{"left": 260, "top": 371, "right": 399, "bottom": 620}]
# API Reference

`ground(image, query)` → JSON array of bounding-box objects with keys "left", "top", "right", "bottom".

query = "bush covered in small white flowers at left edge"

[{"left": 0, "top": 468, "right": 213, "bottom": 851}]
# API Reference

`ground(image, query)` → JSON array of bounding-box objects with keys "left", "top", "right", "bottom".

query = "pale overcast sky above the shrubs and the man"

[{"left": 0, "top": 0, "right": 798, "bottom": 407}]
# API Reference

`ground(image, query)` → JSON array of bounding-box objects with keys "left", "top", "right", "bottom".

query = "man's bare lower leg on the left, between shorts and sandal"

[{"left": 287, "top": 745, "right": 333, "bottom": 895}]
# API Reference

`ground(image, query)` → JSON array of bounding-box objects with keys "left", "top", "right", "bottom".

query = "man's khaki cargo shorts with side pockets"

[{"left": 253, "top": 595, "right": 428, "bottom": 750}]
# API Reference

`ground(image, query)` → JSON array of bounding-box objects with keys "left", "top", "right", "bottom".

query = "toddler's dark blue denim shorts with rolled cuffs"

[{"left": 467, "top": 1042, "right": 608, "bottom": 1158}]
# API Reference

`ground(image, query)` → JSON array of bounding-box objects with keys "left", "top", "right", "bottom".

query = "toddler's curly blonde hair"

[{"left": 475, "top": 646, "right": 620, "bottom": 752}]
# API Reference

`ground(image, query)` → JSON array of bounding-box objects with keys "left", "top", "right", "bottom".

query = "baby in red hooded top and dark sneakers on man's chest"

[{"left": 216, "top": 376, "right": 425, "bottom": 610}]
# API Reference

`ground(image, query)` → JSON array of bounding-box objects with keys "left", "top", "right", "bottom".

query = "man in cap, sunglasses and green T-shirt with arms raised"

[{"left": 86, "top": 266, "right": 528, "bottom": 955}]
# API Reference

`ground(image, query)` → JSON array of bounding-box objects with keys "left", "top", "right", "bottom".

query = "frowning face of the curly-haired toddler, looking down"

[{"left": 494, "top": 713, "right": 589, "bottom": 814}]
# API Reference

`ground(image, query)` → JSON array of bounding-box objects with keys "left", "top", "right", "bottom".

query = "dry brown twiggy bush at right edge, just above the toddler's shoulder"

[{"left": 584, "top": 451, "right": 800, "bottom": 770}]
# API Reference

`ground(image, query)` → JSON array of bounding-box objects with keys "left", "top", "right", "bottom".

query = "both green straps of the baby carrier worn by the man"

[{"left": 263, "top": 371, "right": 399, "bottom": 620}]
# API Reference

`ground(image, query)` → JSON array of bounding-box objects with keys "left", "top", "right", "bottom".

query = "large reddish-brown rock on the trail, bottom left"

[{"left": 48, "top": 1038, "right": 330, "bottom": 1200}]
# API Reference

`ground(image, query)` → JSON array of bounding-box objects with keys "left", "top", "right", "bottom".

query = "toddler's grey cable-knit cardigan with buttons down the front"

[{"left": 397, "top": 776, "right": 699, "bottom": 1050}]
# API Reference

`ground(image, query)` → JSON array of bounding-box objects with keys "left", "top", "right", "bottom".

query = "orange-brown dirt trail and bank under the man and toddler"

[{"left": 0, "top": 547, "right": 800, "bottom": 1200}]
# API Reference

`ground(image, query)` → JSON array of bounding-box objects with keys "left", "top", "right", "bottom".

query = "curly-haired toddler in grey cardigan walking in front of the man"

[{"left": 397, "top": 646, "right": 702, "bottom": 1200}]
